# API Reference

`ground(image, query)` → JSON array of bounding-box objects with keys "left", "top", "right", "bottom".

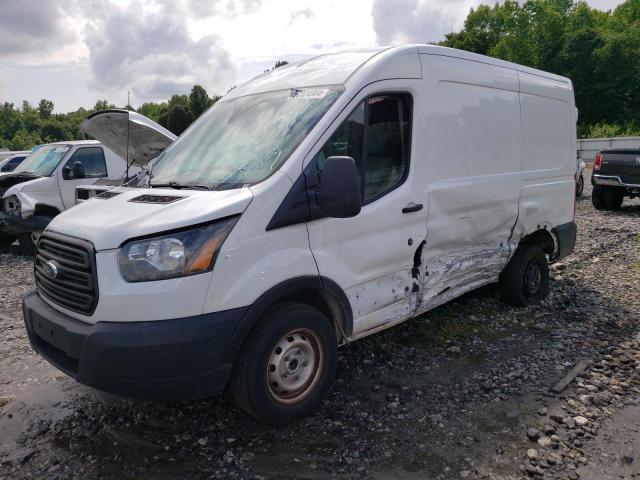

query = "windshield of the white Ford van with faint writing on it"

[{"left": 150, "top": 86, "right": 343, "bottom": 190}]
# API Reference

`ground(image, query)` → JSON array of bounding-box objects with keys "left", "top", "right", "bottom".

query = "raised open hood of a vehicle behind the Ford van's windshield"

[{"left": 80, "top": 110, "right": 178, "bottom": 167}]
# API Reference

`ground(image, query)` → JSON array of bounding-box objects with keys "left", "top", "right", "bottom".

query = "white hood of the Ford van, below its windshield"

[{"left": 47, "top": 187, "right": 253, "bottom": 251}]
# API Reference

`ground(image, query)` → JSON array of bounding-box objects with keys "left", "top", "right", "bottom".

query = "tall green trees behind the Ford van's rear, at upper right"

[{"left": 441, "top": 0, "right": 640, "bottom": 138}]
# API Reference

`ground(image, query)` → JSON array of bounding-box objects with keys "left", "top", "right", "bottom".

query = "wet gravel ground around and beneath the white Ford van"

[{"left": 0, "top": 177, "right": 640, "bottom": 480}]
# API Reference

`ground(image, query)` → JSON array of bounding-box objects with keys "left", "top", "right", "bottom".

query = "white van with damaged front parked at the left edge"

[{"left": 0, "top": 140, "right": 137, "bottom": 253}]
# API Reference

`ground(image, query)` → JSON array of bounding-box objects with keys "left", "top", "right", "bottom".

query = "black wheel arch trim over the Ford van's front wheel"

[{"left": 225, "top": 275, "right": 353, "bottom": 362}]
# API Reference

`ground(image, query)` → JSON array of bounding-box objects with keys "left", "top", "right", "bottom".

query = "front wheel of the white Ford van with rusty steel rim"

[{"left": 231, "top": 303, "right": 337, "bottom": 425}]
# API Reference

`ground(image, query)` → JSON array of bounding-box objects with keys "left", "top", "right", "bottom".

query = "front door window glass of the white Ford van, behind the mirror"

[{"left": 315, "top": 94, "right": 412, "bottom": 203}]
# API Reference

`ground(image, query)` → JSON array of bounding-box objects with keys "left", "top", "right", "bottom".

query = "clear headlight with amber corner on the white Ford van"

[{"left": 118, "top": 217, "right": 238, "bottom": 282}]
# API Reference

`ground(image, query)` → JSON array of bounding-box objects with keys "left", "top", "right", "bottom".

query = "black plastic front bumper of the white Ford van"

[{"left": 22, "top": 291, "right": 246, "bottom": 400}]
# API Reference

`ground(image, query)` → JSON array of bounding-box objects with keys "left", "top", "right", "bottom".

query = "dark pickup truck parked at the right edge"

[{"left": 591, "top": 148, "right": 640, "bottom": 210}]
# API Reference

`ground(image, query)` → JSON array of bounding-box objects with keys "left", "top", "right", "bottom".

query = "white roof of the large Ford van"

[{"left": 223, "top": 44, "right": 570, "bottom": 101}]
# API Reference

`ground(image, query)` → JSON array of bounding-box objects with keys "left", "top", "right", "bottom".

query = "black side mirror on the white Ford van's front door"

[{"left": 316, "top": 157, "right": 362, "bottom": 218}]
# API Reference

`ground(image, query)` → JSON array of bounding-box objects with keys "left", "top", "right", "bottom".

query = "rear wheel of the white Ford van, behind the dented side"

[{"left": 499, "top": 244, "right": 549, "bottom": 307}]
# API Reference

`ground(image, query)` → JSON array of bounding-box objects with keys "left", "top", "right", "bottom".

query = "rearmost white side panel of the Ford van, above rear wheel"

[{"left": 517, "top": 71, "right": 576, "bottom": 235}]
